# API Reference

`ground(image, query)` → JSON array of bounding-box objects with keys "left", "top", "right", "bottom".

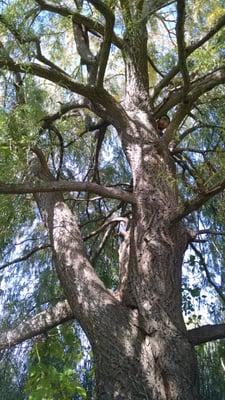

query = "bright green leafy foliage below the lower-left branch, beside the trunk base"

[{"left": 24, "top": 325, "right": 87, "bottom": 400}]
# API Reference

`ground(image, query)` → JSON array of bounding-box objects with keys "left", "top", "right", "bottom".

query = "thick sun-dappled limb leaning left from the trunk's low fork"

[{"left": 31, "top": 149, "right": 122, "bottom": 337}]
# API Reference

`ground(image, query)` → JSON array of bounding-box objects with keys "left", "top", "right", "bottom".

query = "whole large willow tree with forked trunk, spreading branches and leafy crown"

[{"left": 0, "top": 0, "right": 225, "bottom": 400}]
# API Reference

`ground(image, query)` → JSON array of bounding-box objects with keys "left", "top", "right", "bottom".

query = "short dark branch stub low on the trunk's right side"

[{"left": 187, "top": 324, "right": 225, "bottom": 346}]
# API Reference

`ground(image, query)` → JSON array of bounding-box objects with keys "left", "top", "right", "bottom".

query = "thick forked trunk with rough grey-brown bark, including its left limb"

[{"left": 31, "top": 116, "right": 198, "bottom": 400}]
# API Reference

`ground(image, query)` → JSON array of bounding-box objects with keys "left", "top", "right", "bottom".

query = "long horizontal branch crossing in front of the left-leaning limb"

[{"left": 0, "top": 181, "right": 135, "bottom": 204}]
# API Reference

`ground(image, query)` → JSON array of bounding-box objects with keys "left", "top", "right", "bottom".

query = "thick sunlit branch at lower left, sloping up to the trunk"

[{"left": 0, "top": 300, "right": 74, "bottom": 350}]
